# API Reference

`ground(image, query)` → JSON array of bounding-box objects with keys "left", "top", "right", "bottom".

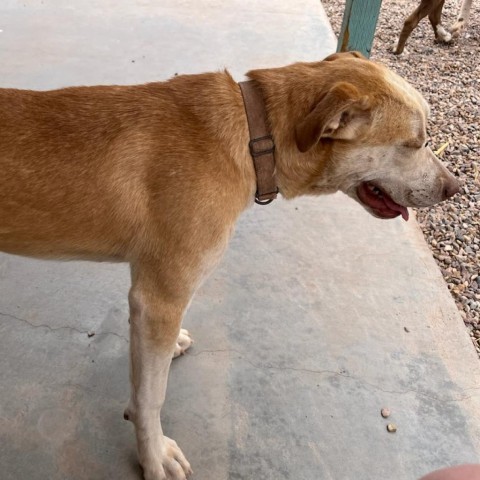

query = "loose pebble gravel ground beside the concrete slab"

[{"left": 322, "top": 0, "right": 480, "bottom": 356}]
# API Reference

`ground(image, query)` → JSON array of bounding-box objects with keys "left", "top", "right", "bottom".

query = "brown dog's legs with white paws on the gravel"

[{"left": 394, "top": 0, "right": 472, "bottom": 55}]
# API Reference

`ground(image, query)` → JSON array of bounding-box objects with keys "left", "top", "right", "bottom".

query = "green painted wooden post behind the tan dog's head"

[{"left": 337, "top": 0, "right": 382, "bottom": 57}]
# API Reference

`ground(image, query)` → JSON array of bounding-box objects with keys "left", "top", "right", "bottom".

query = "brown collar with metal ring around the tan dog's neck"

[{"left": 239, "top": 80, "right": 278, "bottom": 205}]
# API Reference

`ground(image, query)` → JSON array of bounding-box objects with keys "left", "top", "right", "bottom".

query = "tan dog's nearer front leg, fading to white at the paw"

[{"left": 125, "top": 269, "right": 191, "bottom": 480}]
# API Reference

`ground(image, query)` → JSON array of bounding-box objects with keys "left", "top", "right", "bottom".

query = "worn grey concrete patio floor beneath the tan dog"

[{"left": 0, "top": 0, "right": 480, "bottom": 480}]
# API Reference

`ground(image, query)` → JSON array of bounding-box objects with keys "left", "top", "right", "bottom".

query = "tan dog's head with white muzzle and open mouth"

[{"left": 268, "top": 53, "right": 459, "bottom": 220}]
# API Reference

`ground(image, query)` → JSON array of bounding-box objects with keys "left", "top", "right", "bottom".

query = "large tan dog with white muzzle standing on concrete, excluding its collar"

[{"left": 0, "top": 53, "right": 458, "bottom": 480}]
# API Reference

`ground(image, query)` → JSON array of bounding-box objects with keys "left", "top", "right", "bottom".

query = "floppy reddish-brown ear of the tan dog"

[{"left": 295, "top": 82, "right": 370, "bottom": 152}]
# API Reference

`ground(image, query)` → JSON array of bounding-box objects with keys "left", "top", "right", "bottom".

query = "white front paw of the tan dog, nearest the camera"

[{"left": 141, "top": 436, "right": 193, "bottom": 480}]
